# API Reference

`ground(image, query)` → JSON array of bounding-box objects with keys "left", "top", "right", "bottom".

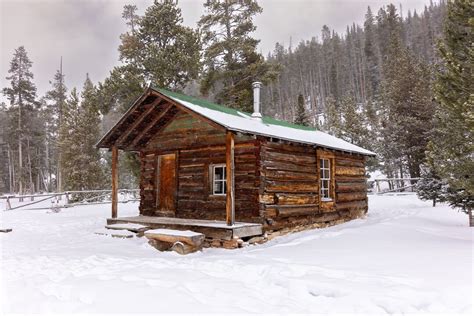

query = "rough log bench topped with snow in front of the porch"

[{"left": 145, "top": 229, "right": 206, "bottom": 255}]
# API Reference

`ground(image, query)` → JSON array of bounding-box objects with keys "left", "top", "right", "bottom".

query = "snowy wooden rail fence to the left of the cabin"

[{"left": 0, "top": 189, "right": 139, "bottom": 211}]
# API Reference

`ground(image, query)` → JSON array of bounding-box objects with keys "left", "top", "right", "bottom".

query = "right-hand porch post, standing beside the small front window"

[{"left": 225, "top": 131, "right": 235, "bottom": 226}]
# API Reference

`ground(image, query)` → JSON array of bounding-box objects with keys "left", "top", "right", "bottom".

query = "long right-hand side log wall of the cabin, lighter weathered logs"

[{"left": 259, "top": 139, "right": 367, "bottom": 231}]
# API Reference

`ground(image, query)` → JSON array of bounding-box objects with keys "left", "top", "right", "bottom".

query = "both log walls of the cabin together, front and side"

[{"left": 140, "top": 112, "right": 367, "bottom": 232}]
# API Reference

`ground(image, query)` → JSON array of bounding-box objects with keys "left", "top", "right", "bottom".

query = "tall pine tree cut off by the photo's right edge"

[{"left": 430, "top": 0, "right": 474, "bottom": 222}]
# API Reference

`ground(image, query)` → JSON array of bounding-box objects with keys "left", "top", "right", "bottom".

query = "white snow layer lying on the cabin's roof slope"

[{"left": 168, "top": 98, "right": 375, "bottom": 155}]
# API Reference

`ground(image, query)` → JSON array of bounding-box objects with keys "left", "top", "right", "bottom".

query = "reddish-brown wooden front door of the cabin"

[{"left": 156, "top": 154, "right": 177, "bottom": 216}]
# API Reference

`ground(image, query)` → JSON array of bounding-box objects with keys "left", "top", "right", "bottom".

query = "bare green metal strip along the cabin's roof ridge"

[{"left": 153, "top": 88, "right": 316, "bottom": 131}]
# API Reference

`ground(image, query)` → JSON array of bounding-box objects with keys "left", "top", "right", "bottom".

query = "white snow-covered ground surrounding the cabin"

[{"left": 0, "top": 196, "right": 474, "bottom": 315}]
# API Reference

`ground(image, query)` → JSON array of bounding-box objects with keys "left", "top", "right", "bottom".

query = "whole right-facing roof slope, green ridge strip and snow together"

[{"left": 154, "top": 89, "right": 375, "bottom": 156}]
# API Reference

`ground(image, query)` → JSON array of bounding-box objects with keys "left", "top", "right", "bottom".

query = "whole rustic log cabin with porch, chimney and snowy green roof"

[{"left": 97, "top": 82, "right": 375, "bottom": 247}]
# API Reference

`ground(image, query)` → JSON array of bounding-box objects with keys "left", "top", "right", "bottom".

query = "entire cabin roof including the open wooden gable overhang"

[{"left": 97, "top": 87, "right": 376, "bottom": 156}]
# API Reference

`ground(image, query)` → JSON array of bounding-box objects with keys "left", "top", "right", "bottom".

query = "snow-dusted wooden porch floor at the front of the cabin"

[{"left": 107, "top": 215, "right": 263, "bottom": 240}]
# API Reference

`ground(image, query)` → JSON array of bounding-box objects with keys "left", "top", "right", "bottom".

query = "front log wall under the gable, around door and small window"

[{"left": 140, "top": 113, "right": 260, "bottom": 222}]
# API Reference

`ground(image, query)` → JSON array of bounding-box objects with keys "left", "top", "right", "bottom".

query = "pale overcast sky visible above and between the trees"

[{"left": 0, "top": 0, "right": 429, "bottom": 100}]
